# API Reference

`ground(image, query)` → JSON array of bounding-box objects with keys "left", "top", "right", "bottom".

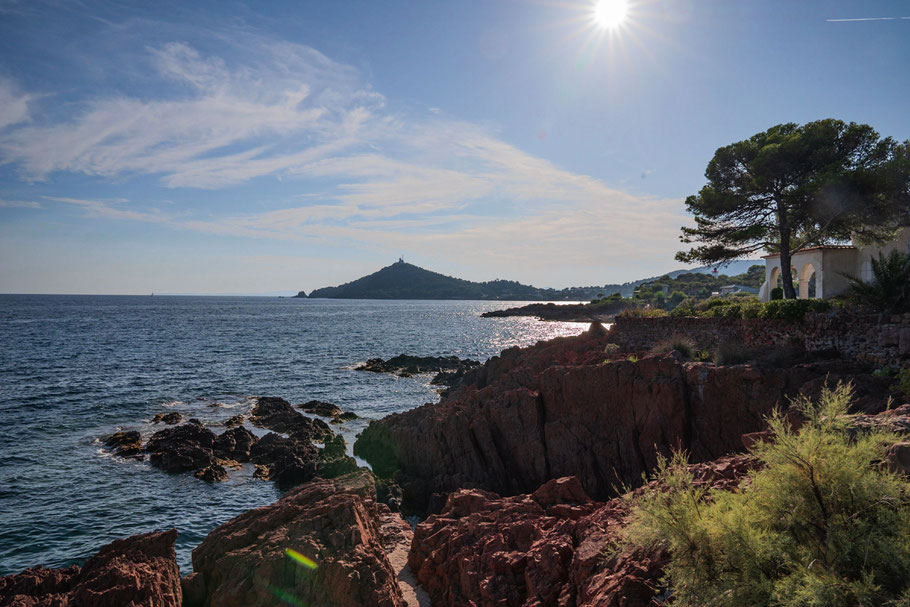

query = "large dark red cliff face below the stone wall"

[{"left": 355, "top": 325, "right": 884, "bottom": 512}]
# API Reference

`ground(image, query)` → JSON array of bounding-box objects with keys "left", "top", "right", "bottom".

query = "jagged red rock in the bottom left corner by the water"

[{"left": 0, "top": 529, "right": 183, "bottom": 607}]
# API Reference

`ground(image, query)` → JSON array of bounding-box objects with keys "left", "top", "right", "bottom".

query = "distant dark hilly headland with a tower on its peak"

[{"left": 295, "top": 259, "right": 754, "bottom": 302}]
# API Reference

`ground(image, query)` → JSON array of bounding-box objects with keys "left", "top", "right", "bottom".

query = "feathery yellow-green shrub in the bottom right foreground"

[{"left": 623, "top": 384, "right": 910, "bottom": 607}]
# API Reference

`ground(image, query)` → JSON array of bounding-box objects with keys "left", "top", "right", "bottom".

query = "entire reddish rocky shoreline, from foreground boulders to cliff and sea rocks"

[{"left": 0, "top": 323, "right": 910, "bottom": 607}]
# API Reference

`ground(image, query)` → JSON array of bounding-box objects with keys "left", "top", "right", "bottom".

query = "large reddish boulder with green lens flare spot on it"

[{"left": 193, "top": 470, "right": 410, "bottom": 607}]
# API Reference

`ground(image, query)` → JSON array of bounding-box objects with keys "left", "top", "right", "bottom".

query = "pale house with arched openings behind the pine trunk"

[{"left": 758, "top": 228, "right": 910, "bottom": 301}]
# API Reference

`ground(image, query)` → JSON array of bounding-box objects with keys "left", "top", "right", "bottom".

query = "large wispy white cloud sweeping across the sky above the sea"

[{"left": 0, "top": 27, "right": 685, "bottom": 282}]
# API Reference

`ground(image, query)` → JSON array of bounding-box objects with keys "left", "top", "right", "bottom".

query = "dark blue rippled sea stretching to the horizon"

[{"left": 0, "top": 295, "right": 586, "bottom": 575}]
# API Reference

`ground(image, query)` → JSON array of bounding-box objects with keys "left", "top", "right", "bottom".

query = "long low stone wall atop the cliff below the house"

[{"left": 609, "top": 310, "right": 910, "bottom": 366}]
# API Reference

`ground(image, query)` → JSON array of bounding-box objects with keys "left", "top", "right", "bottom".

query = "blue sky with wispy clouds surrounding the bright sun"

[{"left": 0, "top": 0, "right": 910, "bottom": 294}]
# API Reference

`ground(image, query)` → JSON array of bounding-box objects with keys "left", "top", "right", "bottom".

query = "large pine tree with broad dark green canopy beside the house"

[{"left": 676, "top": 119, "right": 910, "bottom": 299}]
